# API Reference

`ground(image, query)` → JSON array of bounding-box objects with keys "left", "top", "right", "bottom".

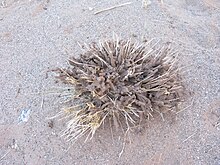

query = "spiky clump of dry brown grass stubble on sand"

[{"left": 54, "top": 38, "right": 183, "bottom": 141}]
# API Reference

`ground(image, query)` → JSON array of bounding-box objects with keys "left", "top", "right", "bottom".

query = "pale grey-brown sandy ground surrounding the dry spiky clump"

[{"left": 0, "top": 0, "right": 220, "bottom": 165}]
